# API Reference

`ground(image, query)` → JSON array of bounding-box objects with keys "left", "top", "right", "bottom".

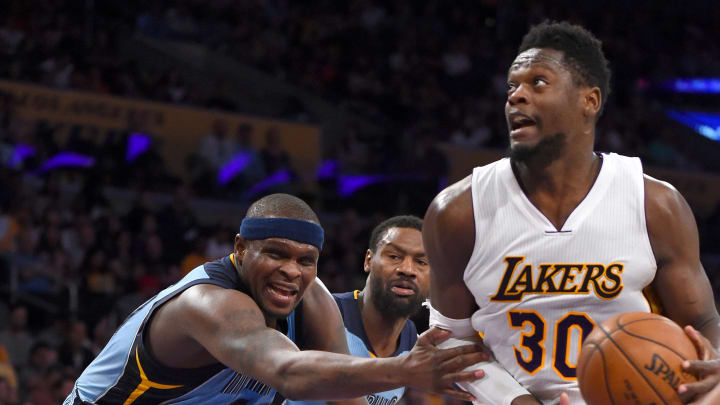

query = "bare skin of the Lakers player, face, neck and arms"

[{"left": 423, "top": 48, "right": 720, "bottom": 405}]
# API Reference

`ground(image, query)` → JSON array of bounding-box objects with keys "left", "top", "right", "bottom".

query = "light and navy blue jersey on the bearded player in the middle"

[{"left": 287, "top": 290, "right": 417, "bottom": 405}]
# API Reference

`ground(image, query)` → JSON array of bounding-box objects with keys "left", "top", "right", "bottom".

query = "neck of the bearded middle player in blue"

[{"left": 358, "top": 288, "right": 408, "bottom": 357}]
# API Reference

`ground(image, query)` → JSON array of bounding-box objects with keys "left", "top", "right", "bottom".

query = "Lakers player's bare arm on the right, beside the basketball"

[{"left": 645, "top": 176, "right": 720, "bottom": 401}]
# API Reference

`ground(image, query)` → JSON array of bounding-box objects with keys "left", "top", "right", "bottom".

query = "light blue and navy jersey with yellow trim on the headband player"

[{"left": 64, "top": 256, "right": 295, "bottom": 405}]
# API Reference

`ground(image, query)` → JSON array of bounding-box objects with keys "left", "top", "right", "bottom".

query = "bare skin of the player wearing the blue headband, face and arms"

[{"left": 143, "top": 235, "right": 486, "bottom": 400}]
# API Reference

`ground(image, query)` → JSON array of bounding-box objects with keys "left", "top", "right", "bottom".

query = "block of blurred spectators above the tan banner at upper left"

[{"left": 0, "top": 0, "right": 240, "bottom": 110}]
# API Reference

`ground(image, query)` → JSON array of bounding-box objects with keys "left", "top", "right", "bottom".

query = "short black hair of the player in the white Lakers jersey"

[{"left": 518, "top": 20, "right": 611, "bottom": 117}]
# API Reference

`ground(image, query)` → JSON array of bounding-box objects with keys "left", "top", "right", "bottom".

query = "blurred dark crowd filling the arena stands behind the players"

[{"left": 0, "top": 0, "right": 720, "bottom": 405}]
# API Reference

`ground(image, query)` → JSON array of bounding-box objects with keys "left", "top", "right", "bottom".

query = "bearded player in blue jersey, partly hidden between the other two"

[{"left": 291, "top": 215, "right": 430, "bottom": 405}]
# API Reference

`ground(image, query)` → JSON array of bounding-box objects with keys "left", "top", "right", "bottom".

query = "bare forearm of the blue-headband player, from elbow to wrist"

[{"left": 276, "top": 350, "right": 404, "bottom": 400}]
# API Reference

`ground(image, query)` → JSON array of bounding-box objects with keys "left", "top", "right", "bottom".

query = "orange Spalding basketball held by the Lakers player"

[{"left": 577, "top": 312, "right": 698, "bottom": 405}]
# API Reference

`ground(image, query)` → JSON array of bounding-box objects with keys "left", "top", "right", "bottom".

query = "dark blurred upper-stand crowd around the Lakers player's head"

[{"left": 125, "top": 0, "right": 720, "bottom": 168}]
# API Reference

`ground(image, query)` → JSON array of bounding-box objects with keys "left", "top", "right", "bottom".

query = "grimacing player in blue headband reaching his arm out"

[{"left": 64, "top": 194, "right": 486, "bottom": 405}]
